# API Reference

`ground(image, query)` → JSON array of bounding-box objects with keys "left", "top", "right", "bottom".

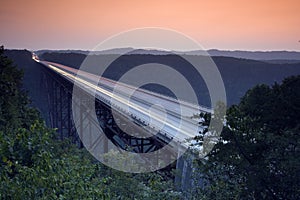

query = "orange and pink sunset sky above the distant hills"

[{"left": 0, "top": 0, "right": 300, "bottom": 51}]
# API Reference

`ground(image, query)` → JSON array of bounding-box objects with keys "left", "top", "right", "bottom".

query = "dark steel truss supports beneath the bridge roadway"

[{"left": 42, "top": 67, "right": 177, "bottom": 166}]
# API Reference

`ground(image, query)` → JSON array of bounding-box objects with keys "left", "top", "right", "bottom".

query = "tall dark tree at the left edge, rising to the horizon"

[{"left": 0, "top": 46, "right": 37, "bottom": 131}]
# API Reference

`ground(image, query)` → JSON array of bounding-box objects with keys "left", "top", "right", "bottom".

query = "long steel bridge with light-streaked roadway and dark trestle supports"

[{"left": 32, "top": 53, "right": 212, "bottom": 177}]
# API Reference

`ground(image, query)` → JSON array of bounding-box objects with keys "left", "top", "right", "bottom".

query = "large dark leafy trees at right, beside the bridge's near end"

[{"left": 194, "top": 76, "right": 300, "bottom": 199}]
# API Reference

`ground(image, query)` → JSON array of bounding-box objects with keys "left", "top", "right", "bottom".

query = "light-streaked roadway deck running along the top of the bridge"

[{"left": 32, "top": 54, "right": 212, "bottom": 147}]
